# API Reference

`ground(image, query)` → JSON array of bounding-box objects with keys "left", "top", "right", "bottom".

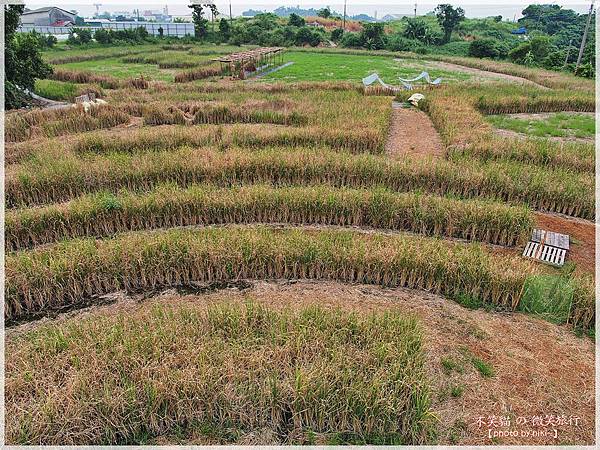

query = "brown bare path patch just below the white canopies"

[{"left": 385, "top": 106, "right": 445, "bottom": 159}]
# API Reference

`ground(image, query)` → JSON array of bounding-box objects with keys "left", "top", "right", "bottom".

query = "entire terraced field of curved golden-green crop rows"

[{"left": 5, "top": 43, "right": 595, "bottom": 445}]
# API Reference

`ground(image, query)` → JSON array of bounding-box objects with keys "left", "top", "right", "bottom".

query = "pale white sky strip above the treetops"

[{"left": 25, "top": 0, "right": 590, "bottom": 19}]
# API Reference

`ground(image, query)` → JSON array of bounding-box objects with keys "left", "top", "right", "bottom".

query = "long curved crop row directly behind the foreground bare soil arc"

[{"left": 5, "top": 227, "right": 533, "bottom": 320}]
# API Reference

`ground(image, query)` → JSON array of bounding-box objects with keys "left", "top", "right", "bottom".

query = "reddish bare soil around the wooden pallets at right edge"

[{"left": 535, "top": 212, "right": 596, "bottom": 275}]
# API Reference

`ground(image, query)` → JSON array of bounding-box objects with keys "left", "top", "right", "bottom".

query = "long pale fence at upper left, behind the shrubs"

[{"left": 17, "top": 22, "right": 194, "bottom": 37}]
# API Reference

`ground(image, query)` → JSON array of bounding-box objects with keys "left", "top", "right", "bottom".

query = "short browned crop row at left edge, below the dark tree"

[{"left": 4, "top": 105, "right": 130, "bottom": 142}]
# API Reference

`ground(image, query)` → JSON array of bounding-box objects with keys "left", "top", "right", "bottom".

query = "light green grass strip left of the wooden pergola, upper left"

[{"left": 59, "top": 58, "right": 180, "bottom": 81}]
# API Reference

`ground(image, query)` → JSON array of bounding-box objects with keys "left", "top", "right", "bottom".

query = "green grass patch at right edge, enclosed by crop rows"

[{"left": 487, "top": 112, "right": 596, "bottom": 138}]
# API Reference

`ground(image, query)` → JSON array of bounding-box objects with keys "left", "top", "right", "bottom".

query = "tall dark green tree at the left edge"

[{"left": 4, "top": 5, "right": 52, "bottom": 109}]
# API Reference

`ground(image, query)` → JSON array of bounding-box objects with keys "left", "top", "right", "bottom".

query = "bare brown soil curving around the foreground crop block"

[{"left": 7, "top": 281, "right": 595, "bottom": 445}]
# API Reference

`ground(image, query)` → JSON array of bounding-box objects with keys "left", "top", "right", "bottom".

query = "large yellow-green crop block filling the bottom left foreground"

[{"left": 6, "top": 303, "right": 433, "bottom": 445}]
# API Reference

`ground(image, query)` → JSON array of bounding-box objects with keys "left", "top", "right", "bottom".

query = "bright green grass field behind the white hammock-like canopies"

[{"left": 262, "top": 52, "right": 470, "bottom": 85}]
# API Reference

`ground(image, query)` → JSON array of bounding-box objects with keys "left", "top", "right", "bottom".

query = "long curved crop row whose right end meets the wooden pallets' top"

[{"left": 5, "top": 186, "right": 533, "bottom": 250}]
